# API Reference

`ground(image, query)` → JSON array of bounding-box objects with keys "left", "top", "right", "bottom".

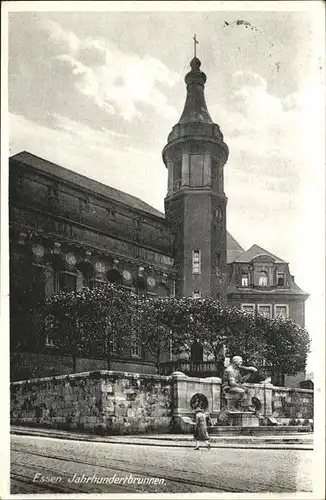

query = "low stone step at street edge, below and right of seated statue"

[{"left": 208, "top": 425, "right": 311, "bottom": 436}]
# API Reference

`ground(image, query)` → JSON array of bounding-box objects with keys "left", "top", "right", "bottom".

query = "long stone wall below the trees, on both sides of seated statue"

[{"left": 11, "top": 370, "right": 313, "bottom": 435}]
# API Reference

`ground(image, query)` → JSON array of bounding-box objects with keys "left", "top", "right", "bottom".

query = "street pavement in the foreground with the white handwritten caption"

[{"left": 11, "top": 435, "right": 313, "bottom": 494}]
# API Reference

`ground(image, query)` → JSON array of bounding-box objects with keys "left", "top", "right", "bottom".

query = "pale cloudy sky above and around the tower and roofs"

[{"left": 5, "top": 2, "right": 324, "bottom": 372}]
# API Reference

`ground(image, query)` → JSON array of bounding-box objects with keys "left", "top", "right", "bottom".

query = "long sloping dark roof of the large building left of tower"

[{"left": 10, "top": 151, "right": 165, "bottom": 219}]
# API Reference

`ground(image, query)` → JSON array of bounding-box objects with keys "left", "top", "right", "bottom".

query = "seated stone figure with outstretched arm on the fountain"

[{"left": 222, "top": 356, "right": 257, "bottom": 411}]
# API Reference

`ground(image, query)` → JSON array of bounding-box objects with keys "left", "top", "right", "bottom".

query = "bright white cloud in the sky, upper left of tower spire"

[{"left": 42, "top": 22, "right": 179, "bottom": 121}]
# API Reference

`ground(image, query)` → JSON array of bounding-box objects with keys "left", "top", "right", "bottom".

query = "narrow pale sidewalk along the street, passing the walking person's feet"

[{"left": 10, "top": 426, "right": 313, "bottom": 450}]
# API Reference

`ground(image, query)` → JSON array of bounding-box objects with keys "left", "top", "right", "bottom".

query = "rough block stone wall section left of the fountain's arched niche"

[{"left": 10, "top": 371, "right": 172, "bottom": 435}]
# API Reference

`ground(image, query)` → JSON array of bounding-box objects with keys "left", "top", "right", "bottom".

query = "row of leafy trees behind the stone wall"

[{"left": 45, "top": 284, "right": 310, "bottom": 383}]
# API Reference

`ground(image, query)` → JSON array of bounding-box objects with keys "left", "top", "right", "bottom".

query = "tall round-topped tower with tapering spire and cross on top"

[{"left": 162, "top": 49, "right": 229, "bottom": 301}]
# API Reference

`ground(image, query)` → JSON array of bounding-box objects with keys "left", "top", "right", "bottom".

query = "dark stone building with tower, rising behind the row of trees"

[{"left": 9, "top": 58, "right": 308, "bottom": 382}]
